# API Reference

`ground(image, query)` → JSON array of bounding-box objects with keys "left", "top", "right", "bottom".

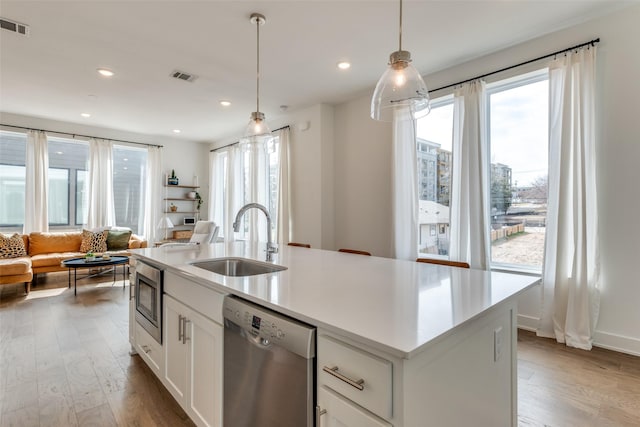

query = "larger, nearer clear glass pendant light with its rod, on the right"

[{"left": 371, "top": 0, "right": 431, "bottom": 122}]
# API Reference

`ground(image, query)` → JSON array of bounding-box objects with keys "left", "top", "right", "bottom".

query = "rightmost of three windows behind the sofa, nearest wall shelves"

[{"left": 113, "top": 145, "right": 147, "bottom": 234}]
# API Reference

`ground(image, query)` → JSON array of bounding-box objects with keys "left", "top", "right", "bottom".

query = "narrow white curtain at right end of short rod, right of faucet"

[{"left": 275, "top": 127, "right": 291, "bottom": 245}]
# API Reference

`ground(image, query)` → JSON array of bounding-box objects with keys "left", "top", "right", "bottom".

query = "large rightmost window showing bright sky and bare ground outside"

[{"left": 487, "top": 70, "right": 549, "bottom": 268}]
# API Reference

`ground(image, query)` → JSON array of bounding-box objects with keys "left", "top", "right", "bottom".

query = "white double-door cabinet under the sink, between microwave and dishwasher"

[{"left": 162, "top": 272, "right": 223, "bottom": 426}]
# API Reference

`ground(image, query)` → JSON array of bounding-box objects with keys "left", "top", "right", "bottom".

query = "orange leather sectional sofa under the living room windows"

[{"left": 0, "top": 231, "right": 147, "bottom": 293}]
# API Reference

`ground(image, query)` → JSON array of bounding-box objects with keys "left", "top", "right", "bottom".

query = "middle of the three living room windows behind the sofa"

[{"left": 47, "top": 136, "right": 89, "bottom": 230}]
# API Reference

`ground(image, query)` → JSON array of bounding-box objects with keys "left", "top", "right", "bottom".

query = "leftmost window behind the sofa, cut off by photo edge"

[{"left": 0, "top": 131, "right": 27, "bottom": 232}]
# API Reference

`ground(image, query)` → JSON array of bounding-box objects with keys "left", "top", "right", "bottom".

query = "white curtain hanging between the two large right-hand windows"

[{"left": 449, "top": 81, "right": 491, "bottom": 270}]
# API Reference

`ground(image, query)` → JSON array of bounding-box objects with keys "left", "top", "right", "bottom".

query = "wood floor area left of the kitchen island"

[{"left": 0, "top": 272, "right": 194, "bottom": 427}]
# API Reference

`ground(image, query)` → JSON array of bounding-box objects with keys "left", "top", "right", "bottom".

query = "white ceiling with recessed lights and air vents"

[{"left": 0, "top": 0, "right": 622, "bottom": 141}]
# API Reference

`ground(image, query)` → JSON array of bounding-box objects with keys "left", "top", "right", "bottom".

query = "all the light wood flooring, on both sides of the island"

[{"left": 0, "top": 273, "right": 640, "bottom": 427}]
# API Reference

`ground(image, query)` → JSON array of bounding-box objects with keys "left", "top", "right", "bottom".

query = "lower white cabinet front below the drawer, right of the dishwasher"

[{"left": 316, "top": 386, "right": 392, "bottom": 427}]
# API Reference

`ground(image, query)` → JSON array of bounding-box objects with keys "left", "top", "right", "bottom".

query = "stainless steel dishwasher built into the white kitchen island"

[{"left": 223, "top": 296, "right": 316, "bottom": 427}]
